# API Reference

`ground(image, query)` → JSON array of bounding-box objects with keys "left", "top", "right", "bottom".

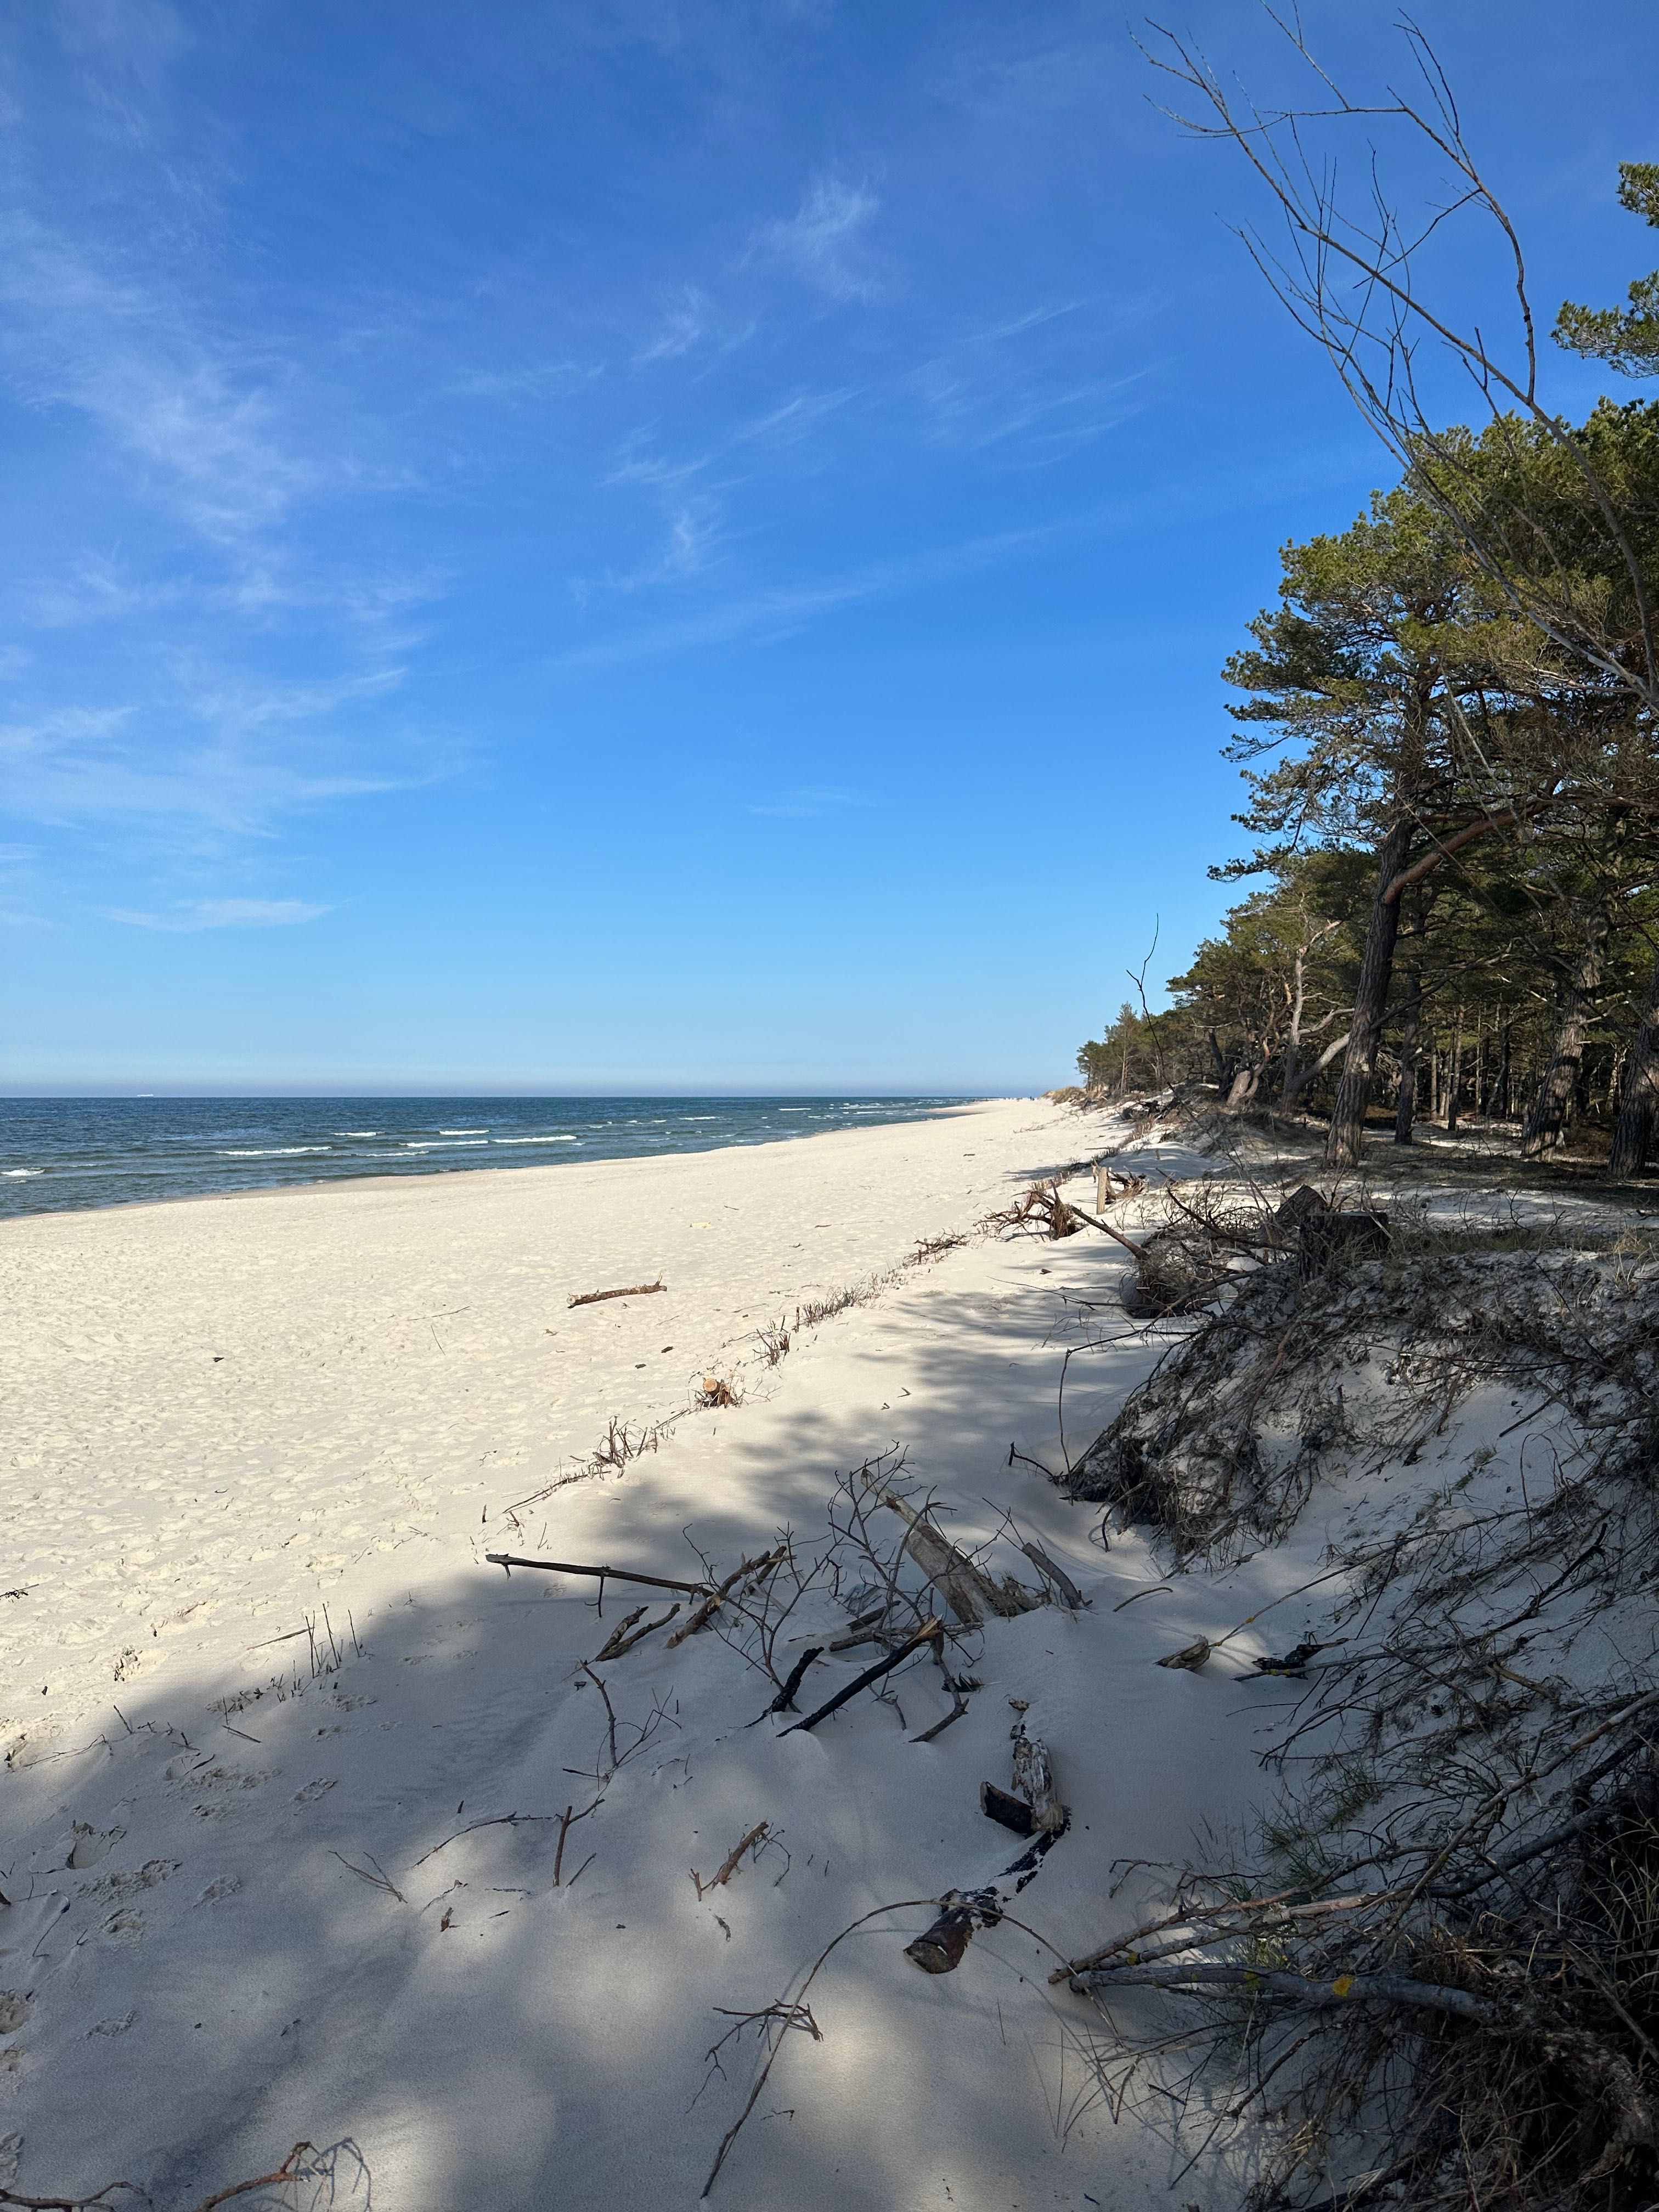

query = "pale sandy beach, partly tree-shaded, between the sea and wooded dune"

[{"left": 0, "top": 1102, "right": 1389, "bottom": 2212}]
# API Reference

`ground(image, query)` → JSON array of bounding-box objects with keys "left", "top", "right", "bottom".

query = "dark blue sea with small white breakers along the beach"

[{"left": 0, "top": 1097, "right": 973, "bottom": 1217}]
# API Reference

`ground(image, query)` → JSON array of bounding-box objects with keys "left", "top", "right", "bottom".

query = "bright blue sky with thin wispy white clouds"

[{"left": 0, "top": 0, "right": 1659, "bottom": 1095}]
